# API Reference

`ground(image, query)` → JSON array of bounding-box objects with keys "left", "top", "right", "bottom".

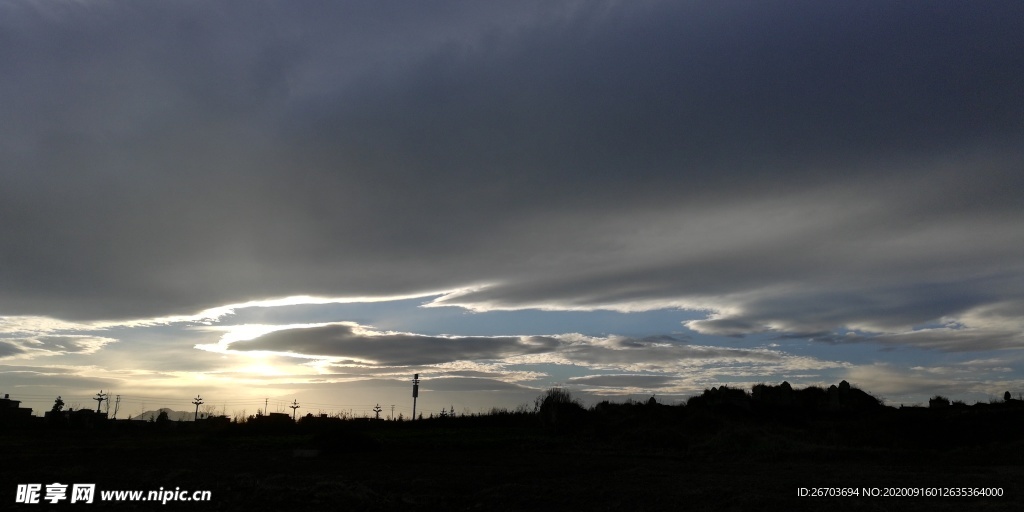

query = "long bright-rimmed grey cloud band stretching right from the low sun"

[{"left": 220, "top": 323, "right": 844, "bottom": 383}]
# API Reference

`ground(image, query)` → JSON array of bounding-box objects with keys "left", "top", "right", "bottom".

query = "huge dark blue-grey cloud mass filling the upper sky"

[{"left": 0, "top": 1, "right": 1024, "bottom": 350}]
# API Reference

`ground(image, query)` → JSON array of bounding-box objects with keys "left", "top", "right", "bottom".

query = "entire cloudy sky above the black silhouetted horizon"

[{"left": 0, "top": 0, "right": 1024, "bottom": 418}]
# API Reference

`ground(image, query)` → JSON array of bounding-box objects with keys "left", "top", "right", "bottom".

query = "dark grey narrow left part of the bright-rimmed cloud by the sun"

[{"left": 228, "top": 324, "right": 559, "bottom": 366}]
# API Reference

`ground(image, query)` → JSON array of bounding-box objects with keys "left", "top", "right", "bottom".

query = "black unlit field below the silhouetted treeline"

[{"left": 0, "top": 403, "right": 1024, "bottom": 512}]
